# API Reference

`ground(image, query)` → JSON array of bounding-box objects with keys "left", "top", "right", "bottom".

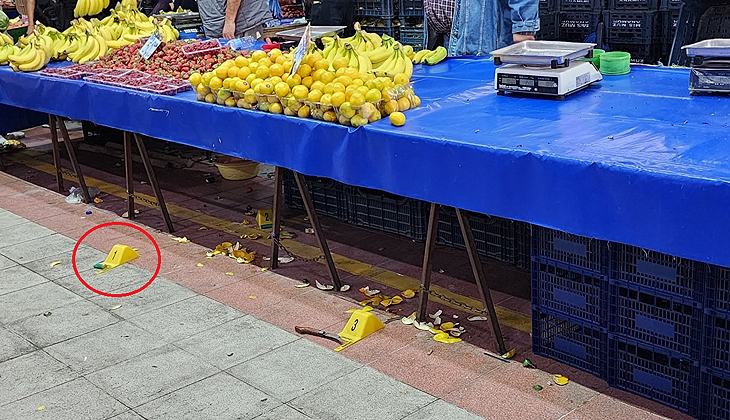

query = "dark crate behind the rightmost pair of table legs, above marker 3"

[{"left": 436, "top": 207, "right": 517, "bottom": 264}]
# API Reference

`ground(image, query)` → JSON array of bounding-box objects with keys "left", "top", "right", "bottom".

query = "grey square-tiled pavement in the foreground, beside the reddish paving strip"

[{"left": 0, "top": 210, "right": 490, "bottom": 420}]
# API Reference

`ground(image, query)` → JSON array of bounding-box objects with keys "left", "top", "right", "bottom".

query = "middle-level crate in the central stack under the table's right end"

[{"left": 609, "top": 280, "right": 703, "bottom": 360}]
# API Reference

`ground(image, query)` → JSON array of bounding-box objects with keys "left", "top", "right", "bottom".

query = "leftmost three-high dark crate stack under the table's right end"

[{"left": 531, "top": 226, "right": 609, "bottom": 378}]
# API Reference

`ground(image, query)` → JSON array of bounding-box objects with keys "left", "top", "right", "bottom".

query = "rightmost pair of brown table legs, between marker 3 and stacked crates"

[{"left": 418, "top": 203, "right": 507, "bottom": 354}]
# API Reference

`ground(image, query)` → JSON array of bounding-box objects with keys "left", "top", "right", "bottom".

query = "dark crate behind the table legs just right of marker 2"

[{"left": 282, "top": 170, "right": 350, "bottom": 221}]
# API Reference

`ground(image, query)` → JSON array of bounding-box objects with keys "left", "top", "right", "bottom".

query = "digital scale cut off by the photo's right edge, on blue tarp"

[{"left": 682, "top": 39, "right": 730, "bottom": 95}]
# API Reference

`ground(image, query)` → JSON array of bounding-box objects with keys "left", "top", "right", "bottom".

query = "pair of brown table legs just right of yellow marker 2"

[{"left": 269, "top": 167, "right": 342, "bottom": 290}]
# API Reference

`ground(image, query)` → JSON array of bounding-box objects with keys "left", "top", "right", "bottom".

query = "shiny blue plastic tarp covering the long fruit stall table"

[{"left": 0, "top": 59, "right": 730, "bottom": 266}]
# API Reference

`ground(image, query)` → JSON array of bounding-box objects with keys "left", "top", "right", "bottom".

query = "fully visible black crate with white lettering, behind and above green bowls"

[{"left": 603, "top": 11, "right": 663, "bottom": 44}]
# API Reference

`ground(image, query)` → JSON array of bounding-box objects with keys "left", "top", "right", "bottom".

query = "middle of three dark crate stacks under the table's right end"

[{"left": 609, "top": 243, "right": 707, "bottom": 415}]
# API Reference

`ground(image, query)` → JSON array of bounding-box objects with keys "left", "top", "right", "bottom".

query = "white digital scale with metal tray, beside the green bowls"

[{"left": 492, "top": 41, "right": 603, "bottom": 100}]
